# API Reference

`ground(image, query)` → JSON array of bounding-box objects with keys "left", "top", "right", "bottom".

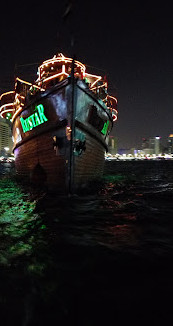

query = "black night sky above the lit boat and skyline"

[{"left": 0, "top": 1, "right": 173, "bottom": 148}]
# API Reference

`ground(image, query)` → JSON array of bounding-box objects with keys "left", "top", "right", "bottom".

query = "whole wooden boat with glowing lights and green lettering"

[{"left": 0, "top": 53, "right": 117, "bottom": 192}]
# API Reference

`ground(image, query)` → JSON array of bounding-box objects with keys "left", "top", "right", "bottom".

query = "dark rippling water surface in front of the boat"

[{"left": 0, "top": 161, "right": 173, "bottom": 326}]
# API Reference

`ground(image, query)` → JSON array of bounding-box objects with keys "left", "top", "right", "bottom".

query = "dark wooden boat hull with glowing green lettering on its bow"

[{"left": 13, "top": 80, "right": 112, "bottom": 193}]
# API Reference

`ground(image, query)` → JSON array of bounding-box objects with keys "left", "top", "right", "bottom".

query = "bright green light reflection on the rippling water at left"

[{"left": 0, "top": 177, "right": 41, "bottom": 266}]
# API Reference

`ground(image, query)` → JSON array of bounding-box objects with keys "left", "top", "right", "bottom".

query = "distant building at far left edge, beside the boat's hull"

[{"left": 0, "top": 118, "right": 13, "bottom": 156}]
